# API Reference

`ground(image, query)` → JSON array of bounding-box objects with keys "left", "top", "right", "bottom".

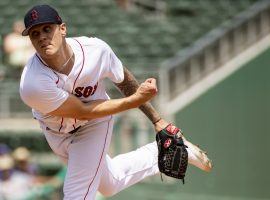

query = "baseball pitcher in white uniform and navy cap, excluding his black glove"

[{"left": 20, "top": 5, "right": 211, "bottom": 200}]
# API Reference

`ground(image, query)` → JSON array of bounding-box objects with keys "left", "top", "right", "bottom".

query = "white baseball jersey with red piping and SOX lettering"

[{"left": 20, "top": 37, "right": 124, "bottom": 133}]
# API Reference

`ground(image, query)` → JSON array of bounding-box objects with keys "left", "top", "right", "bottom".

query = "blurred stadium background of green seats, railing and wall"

[{"left": 0, "top": 0, "right": 270, "bottom": 200}]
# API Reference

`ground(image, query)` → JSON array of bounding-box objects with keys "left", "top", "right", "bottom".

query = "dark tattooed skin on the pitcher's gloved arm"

[{"left": 115, "top": 68, "right": 160, "bottom": 122}]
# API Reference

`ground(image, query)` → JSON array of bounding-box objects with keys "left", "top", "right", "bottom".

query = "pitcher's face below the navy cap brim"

[{"left": 29, "top": 23, "right": 66, "bottom": 58}]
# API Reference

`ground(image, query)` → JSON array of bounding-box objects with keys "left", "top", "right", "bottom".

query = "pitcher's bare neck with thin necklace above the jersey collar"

[{"left": 42, "top": 44, "right": 75, "bottom": 75}]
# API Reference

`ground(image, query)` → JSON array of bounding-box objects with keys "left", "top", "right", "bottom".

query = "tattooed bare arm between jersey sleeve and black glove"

[{"left": 114, "top": 67, "right": 169, "bottom": 132}]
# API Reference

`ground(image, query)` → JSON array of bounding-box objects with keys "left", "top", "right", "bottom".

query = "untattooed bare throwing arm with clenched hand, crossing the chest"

[{"left": 48, "top": 78, "right": 157, "bottom": 120}]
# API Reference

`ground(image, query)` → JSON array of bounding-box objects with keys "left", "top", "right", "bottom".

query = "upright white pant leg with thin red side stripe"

[{"left": 64, "top": 119, "right": 113, "bottom": 200}]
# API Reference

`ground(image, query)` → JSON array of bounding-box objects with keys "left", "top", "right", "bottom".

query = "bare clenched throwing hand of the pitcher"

[{"left": 133, "top": 78, "right": 158, "bottom": 106}]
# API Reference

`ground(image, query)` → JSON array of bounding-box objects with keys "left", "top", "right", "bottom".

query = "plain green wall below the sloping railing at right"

[{"left": 107, "top": 49, "right": 270, "bottom": 200}]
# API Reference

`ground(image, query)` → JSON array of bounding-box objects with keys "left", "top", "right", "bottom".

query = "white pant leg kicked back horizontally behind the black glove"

[{"left": 98, "top": 142, "right": 159, "bottom": 196}]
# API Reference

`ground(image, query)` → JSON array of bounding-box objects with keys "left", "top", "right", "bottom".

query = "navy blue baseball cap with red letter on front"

[{"left": 22, "top": 5, "right": 62, "bottom": 36}]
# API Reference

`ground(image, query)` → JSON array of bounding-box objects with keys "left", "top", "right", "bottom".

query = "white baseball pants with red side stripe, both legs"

[{"left": 43, "top": 118, "right": 159, "bottom": 200}]
